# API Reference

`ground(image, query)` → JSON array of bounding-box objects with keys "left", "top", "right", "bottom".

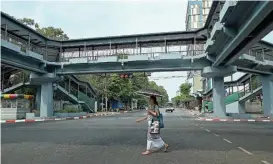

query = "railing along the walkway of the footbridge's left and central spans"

[{"left": 1, "top": 30, "right": 205, "bottom": 62}]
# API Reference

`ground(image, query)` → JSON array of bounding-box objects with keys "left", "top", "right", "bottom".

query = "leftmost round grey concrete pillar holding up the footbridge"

[{"left": 40, "top": 82, "right": 53, "bottom": 117}]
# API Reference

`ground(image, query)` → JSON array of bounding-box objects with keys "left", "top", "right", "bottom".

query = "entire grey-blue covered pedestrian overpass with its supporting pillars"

[{"left": 1, "top": 1, "right": 273, "bottom": 117}]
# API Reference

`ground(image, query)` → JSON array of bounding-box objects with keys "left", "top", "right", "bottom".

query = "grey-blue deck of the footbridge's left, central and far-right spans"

[{"left": 1, "top": 36, "right": 273, "bottom": 75}]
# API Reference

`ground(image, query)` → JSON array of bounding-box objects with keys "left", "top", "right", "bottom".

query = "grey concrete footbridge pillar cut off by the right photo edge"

[{"left": 261, "top": 76, "right": 273, "bottom": 117}]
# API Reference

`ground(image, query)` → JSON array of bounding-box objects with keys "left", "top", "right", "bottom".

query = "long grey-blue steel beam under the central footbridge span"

[{"left": 56, "top": 57, "right": 211, "bottom": 75}]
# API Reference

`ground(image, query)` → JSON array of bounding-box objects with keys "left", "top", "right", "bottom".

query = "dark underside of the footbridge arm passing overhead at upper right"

[{"left": 205, "top": 1, "right": 273, "bottom": 66}]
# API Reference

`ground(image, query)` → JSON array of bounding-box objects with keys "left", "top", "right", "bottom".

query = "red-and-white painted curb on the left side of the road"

[{"left": 1, "top": 113, "right": 120, "bottom": 124}]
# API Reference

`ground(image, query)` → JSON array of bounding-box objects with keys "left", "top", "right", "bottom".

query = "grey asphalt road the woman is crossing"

[{"left": 1, "top": 109, "right": 273, "bottom": 164}]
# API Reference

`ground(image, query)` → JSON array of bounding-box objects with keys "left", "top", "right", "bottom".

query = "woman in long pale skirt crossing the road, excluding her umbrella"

[{"left": 136, "top": 96, "right": 169, "bottom": 155}]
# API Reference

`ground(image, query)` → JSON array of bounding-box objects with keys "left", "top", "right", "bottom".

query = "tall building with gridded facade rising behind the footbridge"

[{"left": 186, "top": 0, "right": 212, "bottom": 93}]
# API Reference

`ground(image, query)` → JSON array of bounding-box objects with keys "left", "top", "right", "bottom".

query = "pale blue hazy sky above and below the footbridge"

[{"left": 1, "top": 0, "right": 273, "bottom": 98}]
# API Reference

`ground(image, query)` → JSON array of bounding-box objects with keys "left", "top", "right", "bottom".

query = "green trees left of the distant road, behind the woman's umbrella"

[{"left": 77, "top": 73, "right": 169, "bottom": 106}]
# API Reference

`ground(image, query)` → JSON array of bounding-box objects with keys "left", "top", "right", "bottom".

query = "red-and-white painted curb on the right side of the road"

[{"left": 197, "top": 117, "right": 273, "bottom": 123}]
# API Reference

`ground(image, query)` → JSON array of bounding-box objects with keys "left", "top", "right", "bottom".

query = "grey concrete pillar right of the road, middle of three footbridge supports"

[{"left": 212, "top": 77, "right": 226, "bottom": 117}]
